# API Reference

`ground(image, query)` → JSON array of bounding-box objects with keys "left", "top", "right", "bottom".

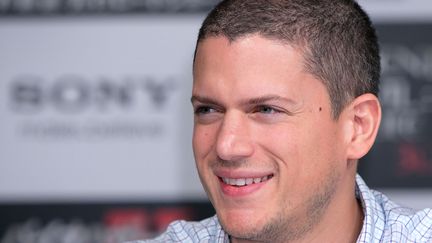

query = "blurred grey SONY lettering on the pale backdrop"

[{"left": 9, "top": 75, "right": 176, "bottom": 114}]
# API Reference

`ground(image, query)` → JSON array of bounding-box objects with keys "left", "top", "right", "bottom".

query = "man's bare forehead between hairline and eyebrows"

[{"left": 193, "top": 35, "right": 328, "bottom": 102}]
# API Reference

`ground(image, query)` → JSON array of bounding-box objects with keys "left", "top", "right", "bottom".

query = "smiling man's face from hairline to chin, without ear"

[{"left": 192, "top": 35, "right": 352, "bottom": 239}]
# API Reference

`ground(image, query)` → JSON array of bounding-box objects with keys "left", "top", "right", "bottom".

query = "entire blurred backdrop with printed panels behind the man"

[{"left": 0, "top": 0, "right": 432, "bottom": 243}]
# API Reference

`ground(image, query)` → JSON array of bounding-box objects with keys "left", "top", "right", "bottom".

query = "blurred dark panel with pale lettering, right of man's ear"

[{"left": 360, "top": 23, "right": 432, "bottom": 188}]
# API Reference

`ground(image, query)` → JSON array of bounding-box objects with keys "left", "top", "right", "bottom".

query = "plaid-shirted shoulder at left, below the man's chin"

[{"left": 126, "top": 216, "right": 226, "bottom": 243}]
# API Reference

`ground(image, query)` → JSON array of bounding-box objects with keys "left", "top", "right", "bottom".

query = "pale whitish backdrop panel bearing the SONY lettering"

[{"left": 0, "top": 16, "right": 206, "bottom": 201}]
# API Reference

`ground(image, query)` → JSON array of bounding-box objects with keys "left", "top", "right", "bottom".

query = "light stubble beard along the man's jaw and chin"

[{"left": 224, "top": 170, "right": 340, "bottom": 243}]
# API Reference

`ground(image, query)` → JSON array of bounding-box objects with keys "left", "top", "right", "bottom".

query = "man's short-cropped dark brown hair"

[{"left": 195, "top": 0, "right": 380, "bottom": 119}]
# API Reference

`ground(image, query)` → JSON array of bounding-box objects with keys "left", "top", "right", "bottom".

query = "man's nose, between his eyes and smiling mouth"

[{"left": 216, "top": 112, "right": 254, "bottom": 162}]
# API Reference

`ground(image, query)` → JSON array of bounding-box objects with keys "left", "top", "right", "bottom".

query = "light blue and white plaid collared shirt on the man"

[{"left": 131, "top": 175, "right": 432, "bottom": 243}]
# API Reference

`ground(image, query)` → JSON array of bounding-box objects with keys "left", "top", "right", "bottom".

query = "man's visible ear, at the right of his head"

[{"left": 347, "top": 94, "right": 381, "bottom": 160}]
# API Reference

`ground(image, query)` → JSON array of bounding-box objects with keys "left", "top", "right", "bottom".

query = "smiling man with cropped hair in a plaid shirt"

[{"left": 133, "top": 0, "right": 432, "bottom": 242}]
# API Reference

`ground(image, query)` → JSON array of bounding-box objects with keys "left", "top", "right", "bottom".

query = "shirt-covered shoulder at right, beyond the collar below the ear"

[{"left": 374, "top": 191, "right": 432, "bottom": 242}]
